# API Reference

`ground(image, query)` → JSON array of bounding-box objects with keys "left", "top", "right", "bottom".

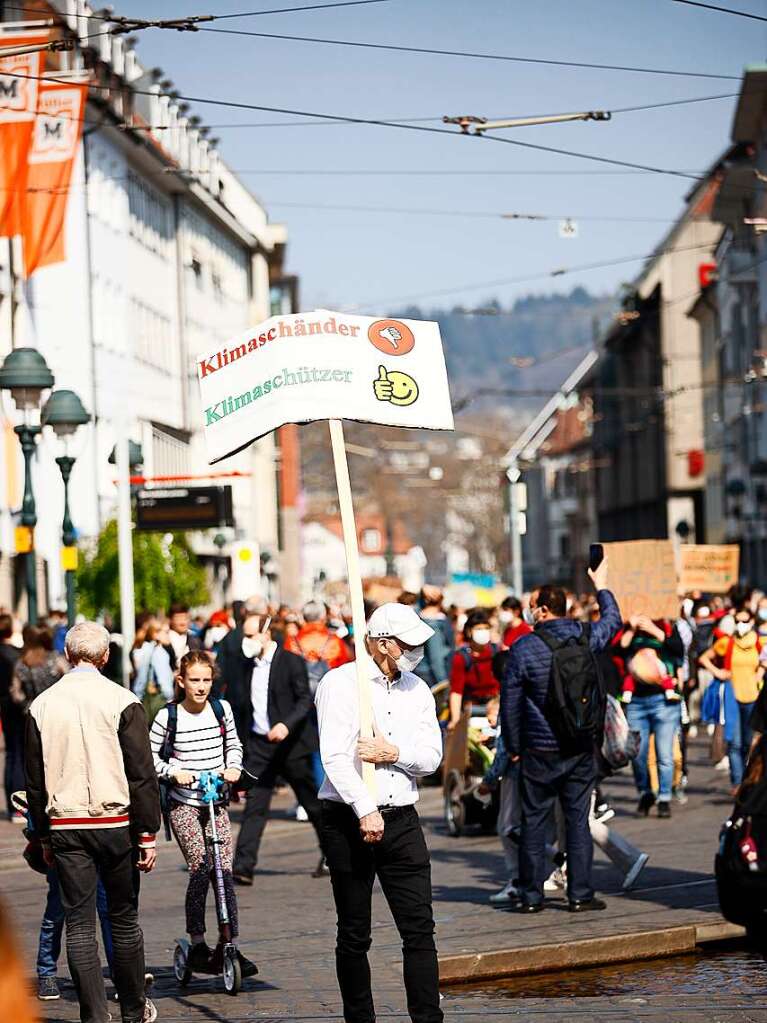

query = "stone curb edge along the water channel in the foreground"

[{"left": 440, "top": 920, "right": 746, "bottom": 984}]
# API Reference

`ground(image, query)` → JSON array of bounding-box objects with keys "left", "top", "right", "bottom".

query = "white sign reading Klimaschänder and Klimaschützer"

[{"left": 197, "top": 309, "right": 453, "bottom": 464}]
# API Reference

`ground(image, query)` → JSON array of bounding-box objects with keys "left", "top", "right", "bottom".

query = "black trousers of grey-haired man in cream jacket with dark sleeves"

[{"left": 51, "top": 828, "right": 145, "bottom": 1023}]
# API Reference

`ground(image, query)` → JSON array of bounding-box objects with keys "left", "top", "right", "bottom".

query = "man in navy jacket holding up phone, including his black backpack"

[{"left": 501, "top": 558, "right": 621, "bottom": 913}]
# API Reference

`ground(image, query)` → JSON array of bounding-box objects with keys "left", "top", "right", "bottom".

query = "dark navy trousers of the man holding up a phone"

[{"left": 520, "top": 751, "right": 596, "bottom": 903}]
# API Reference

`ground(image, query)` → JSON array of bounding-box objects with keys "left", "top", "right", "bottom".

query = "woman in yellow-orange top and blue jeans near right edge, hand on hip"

[{"left": 700, "top": 607, "right": 764, "bottom": 789}]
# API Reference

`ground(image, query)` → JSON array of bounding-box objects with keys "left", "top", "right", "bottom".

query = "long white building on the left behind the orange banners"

[{"left": 0, "top": 0, "right": 286, "bottom": 607}]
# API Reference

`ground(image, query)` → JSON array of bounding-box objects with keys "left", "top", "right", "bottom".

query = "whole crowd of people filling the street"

[{"left": 0, "top": 563, "right": 767, "bottom": 1023}]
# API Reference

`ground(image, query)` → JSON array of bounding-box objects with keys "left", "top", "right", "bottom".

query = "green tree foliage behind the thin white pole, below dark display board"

[{"left": 77, "top": 519, "right": 210, "bottom": 618}]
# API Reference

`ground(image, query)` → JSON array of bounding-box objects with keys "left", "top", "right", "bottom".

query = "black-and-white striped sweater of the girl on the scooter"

[{"left": 149, "top": 700, "right": 242, "bottom": 806}]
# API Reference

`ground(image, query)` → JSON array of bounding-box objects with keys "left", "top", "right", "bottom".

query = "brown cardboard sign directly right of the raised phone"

[{"left": 604, "top": 540, "right": 679, "bottom": 621}]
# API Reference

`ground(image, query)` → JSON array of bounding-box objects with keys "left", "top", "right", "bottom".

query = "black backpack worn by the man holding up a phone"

[{"left": 535, "top": 623, "right": 606, "bottom": 755}]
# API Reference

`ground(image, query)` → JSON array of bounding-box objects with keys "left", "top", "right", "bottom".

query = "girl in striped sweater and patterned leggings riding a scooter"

[{"left": 149, "top": 651, "right": 258, "bottom": 977}]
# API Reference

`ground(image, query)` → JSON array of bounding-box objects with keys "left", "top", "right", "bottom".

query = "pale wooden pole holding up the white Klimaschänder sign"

[{"left": 328, "top": 419, "right": 376, "bottom": 796}]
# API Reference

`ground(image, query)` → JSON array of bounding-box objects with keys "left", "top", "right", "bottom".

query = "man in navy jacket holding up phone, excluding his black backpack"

[{"left": 501, "top": 560, "right": 621, "bottom": 913}]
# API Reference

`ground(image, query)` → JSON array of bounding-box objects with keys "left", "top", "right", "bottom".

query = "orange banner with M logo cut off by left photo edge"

[{"left": 0, "top": 33, "right": 48, "bottom": 238}]
